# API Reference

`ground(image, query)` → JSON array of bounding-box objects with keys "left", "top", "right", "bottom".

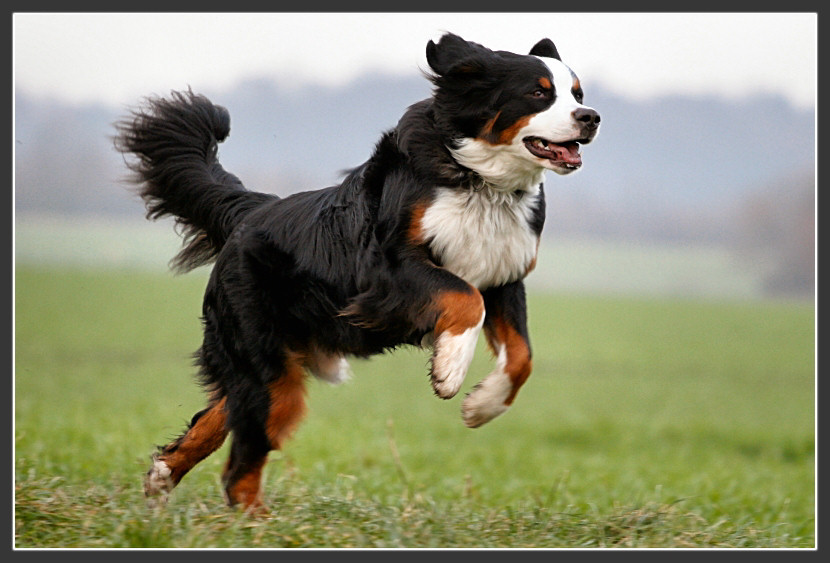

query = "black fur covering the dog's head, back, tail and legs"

[{"left": 116, "top": 34, "right": 600, "bottom": 508}]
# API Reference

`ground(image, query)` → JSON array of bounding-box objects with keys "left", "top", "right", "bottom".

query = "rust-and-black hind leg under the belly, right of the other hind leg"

[{"left": 222, "top": 357, "right": 306, "bottom": 512}]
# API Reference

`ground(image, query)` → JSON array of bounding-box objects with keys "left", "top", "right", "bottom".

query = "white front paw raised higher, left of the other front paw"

[{"left": 431, "top": 315, "right": 484, "bottom": 399}]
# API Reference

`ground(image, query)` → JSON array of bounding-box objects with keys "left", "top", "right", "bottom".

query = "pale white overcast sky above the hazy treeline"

[{"left": 13, "top": 13, "right": 818, "bottom": 108}]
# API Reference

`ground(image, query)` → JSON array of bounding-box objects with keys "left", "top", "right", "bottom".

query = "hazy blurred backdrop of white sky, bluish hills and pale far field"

[{"left": 13, "top": 13, "right": 817, "bottom": 300}]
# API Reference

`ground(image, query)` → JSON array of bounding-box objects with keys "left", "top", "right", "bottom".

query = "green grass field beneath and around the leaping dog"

[{"left": 15, "top": 267, "right": 816, "bottom": 548}]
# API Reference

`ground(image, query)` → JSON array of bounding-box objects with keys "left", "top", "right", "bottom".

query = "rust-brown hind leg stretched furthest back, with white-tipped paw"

[{"left": 144, "top": 398, "right": 228, "bottom": 497}]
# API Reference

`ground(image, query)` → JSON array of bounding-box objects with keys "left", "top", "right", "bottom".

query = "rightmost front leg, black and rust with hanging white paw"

[{"left": 461, "top": 281, "right": 532, "bottom": 428}]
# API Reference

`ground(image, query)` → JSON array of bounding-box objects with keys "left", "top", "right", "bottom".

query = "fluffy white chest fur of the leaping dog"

[{"left": 421, "top": 188, "right": 539, "bottom": 289}]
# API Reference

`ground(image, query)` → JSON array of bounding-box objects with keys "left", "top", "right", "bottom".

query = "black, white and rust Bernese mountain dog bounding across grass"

[{"left": 115, "top": 33, "right": 600, "bottom": 511}]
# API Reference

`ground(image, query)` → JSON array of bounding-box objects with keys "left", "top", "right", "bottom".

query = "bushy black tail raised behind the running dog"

[{"left": 115, "top": 90, "right": 277, "bottom": 272}]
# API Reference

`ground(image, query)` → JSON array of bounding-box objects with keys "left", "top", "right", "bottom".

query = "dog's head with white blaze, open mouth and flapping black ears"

[{"left": 426, "top": 33, "right": 600, "bottom": 189}]
